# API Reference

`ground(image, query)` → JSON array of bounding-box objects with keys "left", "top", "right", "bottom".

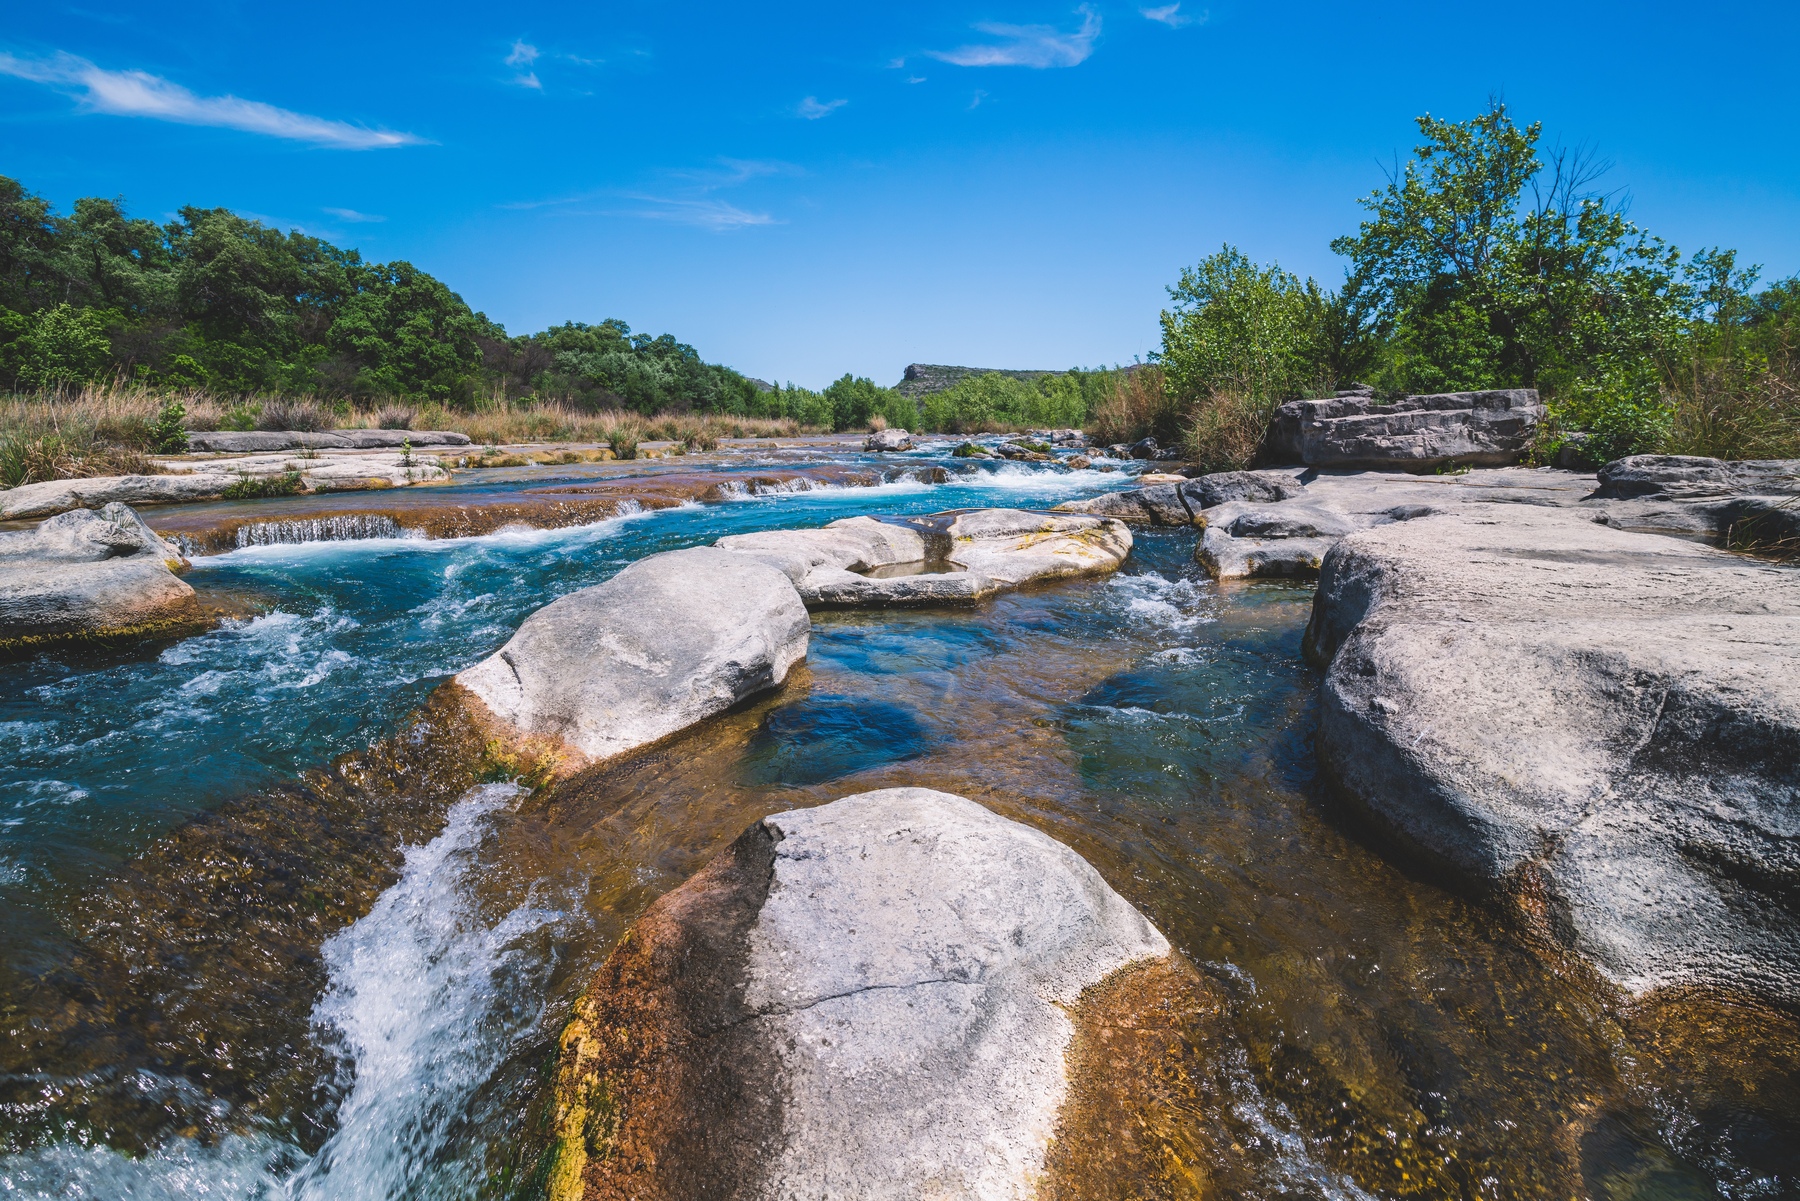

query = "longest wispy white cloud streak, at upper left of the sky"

[{"left": 0, "top": 52, "right": 425, "bottom": 149}]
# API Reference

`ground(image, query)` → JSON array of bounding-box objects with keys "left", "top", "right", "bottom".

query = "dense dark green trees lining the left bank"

[{"left": 0, "top": 176, "right": 758, "bottom": 412}]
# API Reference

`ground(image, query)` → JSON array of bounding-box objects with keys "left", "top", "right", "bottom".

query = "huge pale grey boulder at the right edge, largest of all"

[{"left": 1307, "top": 504, "right": 1800, "bottom": 1005}]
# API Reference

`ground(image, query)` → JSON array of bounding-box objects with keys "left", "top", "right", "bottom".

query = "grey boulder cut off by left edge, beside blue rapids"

[{"left": 0, "top": 502, "right": 196, "bottom": 648}]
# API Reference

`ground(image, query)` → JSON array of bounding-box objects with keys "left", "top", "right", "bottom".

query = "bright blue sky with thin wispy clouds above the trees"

[{"left": 0, "top": 0, "right": 1800, "bottom": 385}]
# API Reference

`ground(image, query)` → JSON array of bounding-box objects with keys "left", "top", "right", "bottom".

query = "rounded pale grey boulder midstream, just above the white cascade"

[{"left": 455, "top": 547, "right": 810, "bottom": 771}]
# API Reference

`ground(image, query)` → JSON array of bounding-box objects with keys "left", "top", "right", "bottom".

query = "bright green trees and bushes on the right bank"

[{"left": 1152, "top": 103, "right": 1800, "bottom": 466}]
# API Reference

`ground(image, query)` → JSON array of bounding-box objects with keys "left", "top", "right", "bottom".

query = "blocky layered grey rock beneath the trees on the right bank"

[{"left": 1258, "top": 389, "right": 1544, "bottom": 472}]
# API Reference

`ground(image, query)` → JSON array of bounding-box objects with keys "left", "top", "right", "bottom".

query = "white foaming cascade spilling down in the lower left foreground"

[{"left": 0, "top": 783, "right": 562, "bottom": 1201}]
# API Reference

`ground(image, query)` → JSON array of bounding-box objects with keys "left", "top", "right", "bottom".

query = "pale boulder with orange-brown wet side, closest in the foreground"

[{"left": 549, "top": 789, "right": 1170, "bottom": 1201}]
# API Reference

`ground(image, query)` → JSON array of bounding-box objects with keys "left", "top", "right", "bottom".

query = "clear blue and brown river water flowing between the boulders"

[{"left": 0, "top": 452, "right": 1800, "bottom": 1201}]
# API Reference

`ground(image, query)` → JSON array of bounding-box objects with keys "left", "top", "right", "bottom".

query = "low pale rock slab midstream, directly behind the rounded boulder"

[{"left": 715, "top": 510, "right": 1130, "bottom": 609}]
